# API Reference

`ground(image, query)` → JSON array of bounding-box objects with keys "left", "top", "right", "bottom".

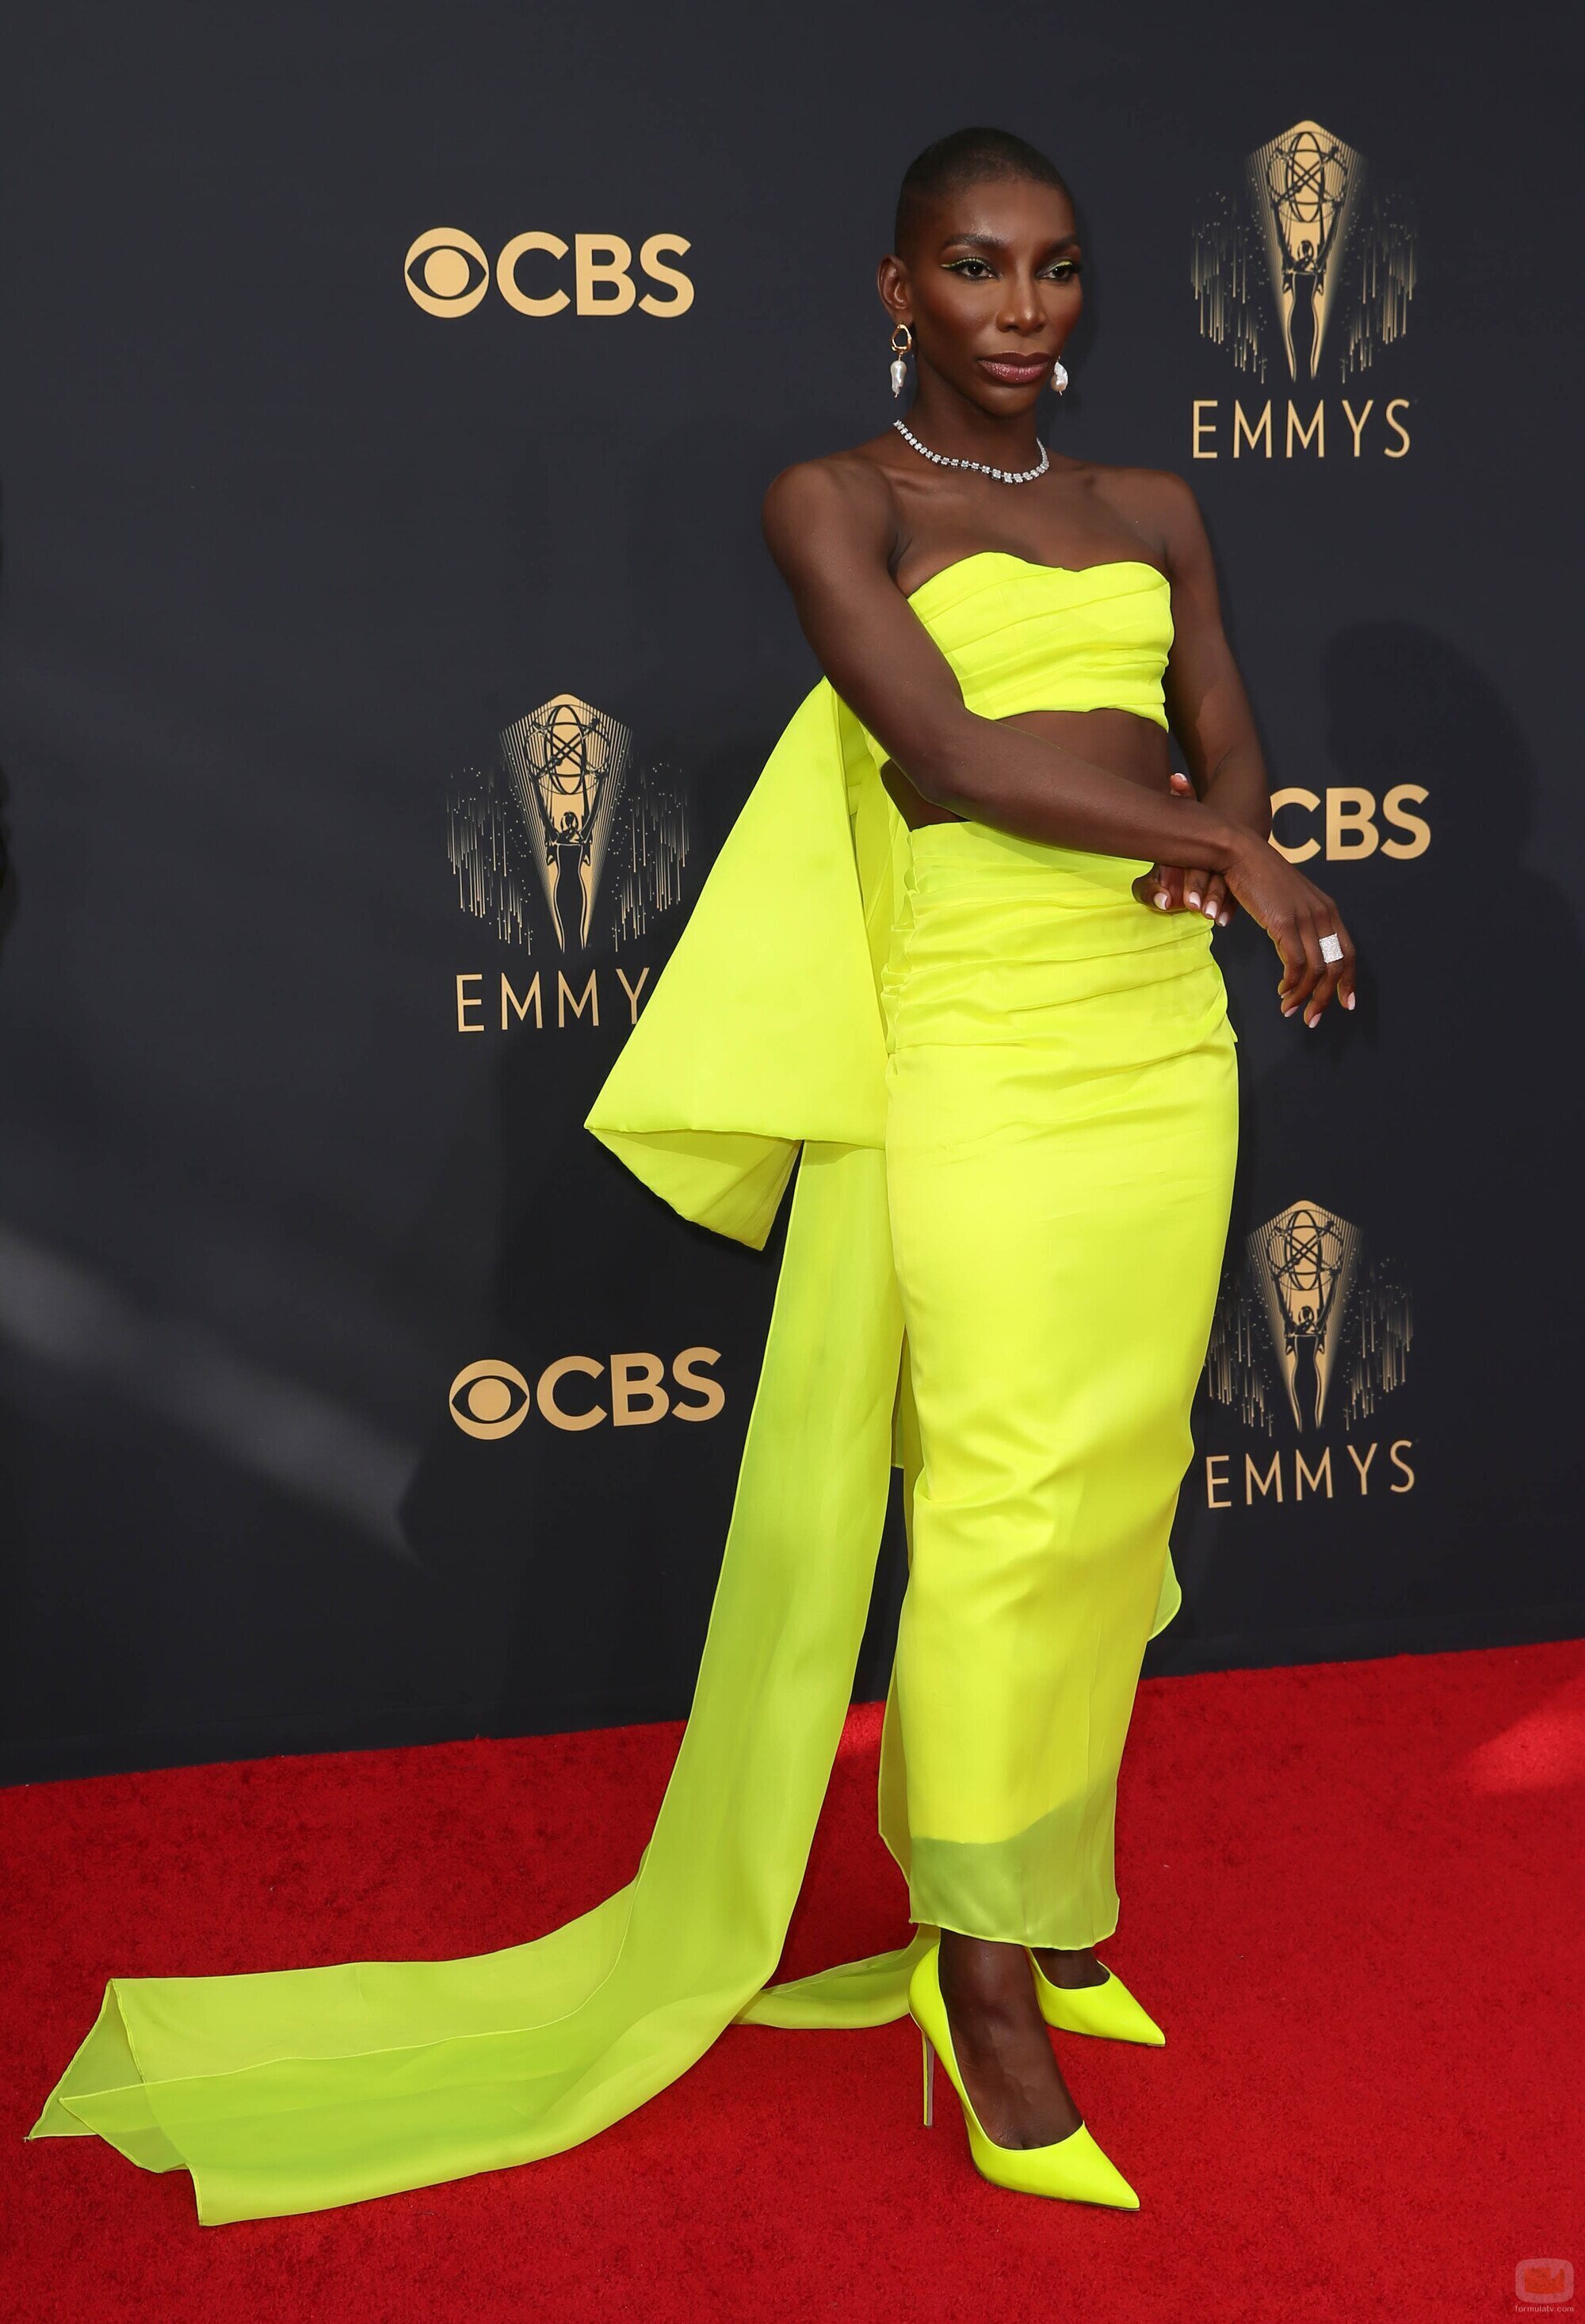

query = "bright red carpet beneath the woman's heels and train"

[{"left": 0, "top": 1641, "right": 1585, "bottom": 2324}]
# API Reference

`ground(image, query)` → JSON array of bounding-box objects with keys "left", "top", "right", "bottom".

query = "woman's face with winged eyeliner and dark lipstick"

[{"left": 879, "top": 177, "right": 1083, "bottom": 418}]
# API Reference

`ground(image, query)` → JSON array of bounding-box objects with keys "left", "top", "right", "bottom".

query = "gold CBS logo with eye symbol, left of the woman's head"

[{"left": 402, "top": 226, "right": 693, "bottom": 319}]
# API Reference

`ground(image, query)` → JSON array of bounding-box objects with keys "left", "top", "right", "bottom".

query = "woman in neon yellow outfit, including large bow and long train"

[{"left": 35, "top": 130, "right": 1353, "bottom": 2222}]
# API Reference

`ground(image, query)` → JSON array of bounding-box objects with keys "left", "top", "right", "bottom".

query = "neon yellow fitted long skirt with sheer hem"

[{"left": 880, "top": 822, "right": 1236, "bottom": 1948}]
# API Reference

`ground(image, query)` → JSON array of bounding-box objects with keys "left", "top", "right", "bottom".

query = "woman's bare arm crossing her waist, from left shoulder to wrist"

[{"left": 765, "top": 460, "right": 1251, "bottom": 872}]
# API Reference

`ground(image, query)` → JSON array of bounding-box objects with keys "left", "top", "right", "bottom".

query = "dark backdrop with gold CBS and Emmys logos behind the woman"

[{"left": 0, "top": 0, "right": 1585, "bottom": 1776}]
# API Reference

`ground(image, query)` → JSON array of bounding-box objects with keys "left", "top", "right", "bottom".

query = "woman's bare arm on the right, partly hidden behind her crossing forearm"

[{"left": 1141, "top": 474, "right": 1271, "bottom": 927}]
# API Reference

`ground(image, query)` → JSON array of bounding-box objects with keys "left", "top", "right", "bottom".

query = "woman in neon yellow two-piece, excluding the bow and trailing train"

[{"left": 748, "top": 130, "right": 1353, "bottom": 2201}]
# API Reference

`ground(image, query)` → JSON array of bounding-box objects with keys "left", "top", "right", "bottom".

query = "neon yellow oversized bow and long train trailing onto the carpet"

[{"left": 30, "top": 560, "right": 1181, "bottom": 2224}]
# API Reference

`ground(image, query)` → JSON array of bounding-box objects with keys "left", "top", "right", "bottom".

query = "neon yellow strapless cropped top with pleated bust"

[{"left": 865, "top": 548, "right": 1171, "bottom": 767}]
